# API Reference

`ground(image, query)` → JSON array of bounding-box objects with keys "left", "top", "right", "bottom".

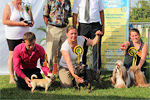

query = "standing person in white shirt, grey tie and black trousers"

[{"left": 72, "top": 0, "right": 104, "bottom": 70}]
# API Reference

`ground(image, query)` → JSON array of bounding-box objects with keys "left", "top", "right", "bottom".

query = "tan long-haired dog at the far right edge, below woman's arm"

[{"left": 129, "top": 66, "right": 150, "bottom": 87}]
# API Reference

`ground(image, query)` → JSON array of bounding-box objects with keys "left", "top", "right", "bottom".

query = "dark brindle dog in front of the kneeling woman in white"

[{"left": 74, "top": 64, "right": 101, "bottom": 93}]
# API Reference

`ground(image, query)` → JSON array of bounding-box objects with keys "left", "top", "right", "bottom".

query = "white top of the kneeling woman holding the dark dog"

[{"left": 59, "top": 36, "right": 85, "bottom": 68}]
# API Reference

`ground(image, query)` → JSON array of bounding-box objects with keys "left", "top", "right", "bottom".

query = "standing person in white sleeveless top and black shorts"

[{"left": 3, "top": 0, "right": 33, "bottom": 84}]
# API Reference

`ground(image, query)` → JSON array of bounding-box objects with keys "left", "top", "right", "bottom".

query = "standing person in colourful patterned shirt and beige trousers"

[{"left": 43, "top": 0, "right": 71, "bottom": 71}]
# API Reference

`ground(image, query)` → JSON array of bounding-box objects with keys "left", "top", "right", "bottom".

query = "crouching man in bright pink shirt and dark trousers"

[{"left": 13, "top": 32, "right": 50, "bottom": 89}]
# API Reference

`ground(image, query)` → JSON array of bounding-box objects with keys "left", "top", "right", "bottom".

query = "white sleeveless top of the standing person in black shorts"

[{"left": 5, "top": 2, "right": 29, "bottom": 39}]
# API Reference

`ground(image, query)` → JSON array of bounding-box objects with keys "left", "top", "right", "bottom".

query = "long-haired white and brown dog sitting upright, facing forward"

[{"left": 110, "top": 60, "right": 131, "bottom": 88}]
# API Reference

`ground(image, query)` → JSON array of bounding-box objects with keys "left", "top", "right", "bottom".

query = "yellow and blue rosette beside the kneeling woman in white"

[{"left": 73, "top": 45, "right": 84, "bottom": 64}]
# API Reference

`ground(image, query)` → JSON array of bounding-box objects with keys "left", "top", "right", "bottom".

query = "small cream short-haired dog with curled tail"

[{"left": 31, "top": 73, "right": 54, "bottom": 93}]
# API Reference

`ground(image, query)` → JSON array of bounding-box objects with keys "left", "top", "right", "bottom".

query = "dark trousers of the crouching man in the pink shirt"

[{"left": 16, "top": 68, "right": 43, "bottom": 89}]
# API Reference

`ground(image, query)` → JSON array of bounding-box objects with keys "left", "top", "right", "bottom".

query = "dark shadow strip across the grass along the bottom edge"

[{"left": 0, "top": 88, "right": 148, "bottom": 100}]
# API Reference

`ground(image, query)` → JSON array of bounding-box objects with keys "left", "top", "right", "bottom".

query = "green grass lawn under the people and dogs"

[{"left": 0, "top": 72, "right": 150, "bottom": 100}]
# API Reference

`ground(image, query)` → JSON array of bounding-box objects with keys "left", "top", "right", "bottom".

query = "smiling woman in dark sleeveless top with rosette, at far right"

[{"left": 120, "top": 28, "right": 148, "bottom": 71}]
